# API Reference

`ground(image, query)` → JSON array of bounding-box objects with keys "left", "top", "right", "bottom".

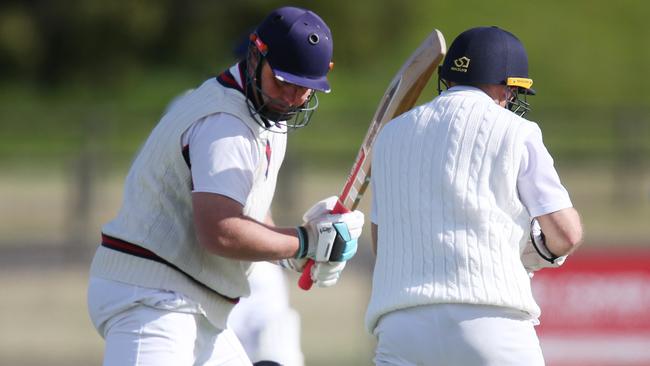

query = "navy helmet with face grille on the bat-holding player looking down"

[{"left": 245, "top": 6, "right": 334, "bottom": 132}]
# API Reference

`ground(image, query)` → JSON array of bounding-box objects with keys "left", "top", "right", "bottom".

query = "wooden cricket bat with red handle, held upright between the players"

[{"left": 298, "top": 29, "right": 447, "bottom": 290}]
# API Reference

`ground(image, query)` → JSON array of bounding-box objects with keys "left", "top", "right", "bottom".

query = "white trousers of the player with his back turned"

[{"left": 374, "top": 304, "right": 544, "bottom": 366}]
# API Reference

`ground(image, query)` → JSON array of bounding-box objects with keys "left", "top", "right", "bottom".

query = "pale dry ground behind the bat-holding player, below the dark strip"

[{"left": 0, "top": 265, "right": 373, "bottom": 366}]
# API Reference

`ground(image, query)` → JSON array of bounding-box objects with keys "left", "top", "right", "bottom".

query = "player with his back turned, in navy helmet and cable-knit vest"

[{"left": 366, "top": 27, "right": 582, "bottom": 366}]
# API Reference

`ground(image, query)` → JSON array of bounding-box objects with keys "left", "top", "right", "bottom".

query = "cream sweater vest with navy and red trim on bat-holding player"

[{"left": 90, "top": 79, "right": 286, "bottom": 329}]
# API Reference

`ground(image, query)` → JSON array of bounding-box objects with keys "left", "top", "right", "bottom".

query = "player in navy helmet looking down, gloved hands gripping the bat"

[{"left": 83, "top": 7, "right": 363, "bottom": 366}]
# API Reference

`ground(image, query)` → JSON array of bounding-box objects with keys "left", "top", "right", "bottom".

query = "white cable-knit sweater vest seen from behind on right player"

[{"left": 366, "top": 86, "right": 540, "bottom": 333}]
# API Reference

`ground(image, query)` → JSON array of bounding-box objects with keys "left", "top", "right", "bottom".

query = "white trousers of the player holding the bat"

[{"left": 88, "top": 277, "right": 251, "bottom": 366}]
